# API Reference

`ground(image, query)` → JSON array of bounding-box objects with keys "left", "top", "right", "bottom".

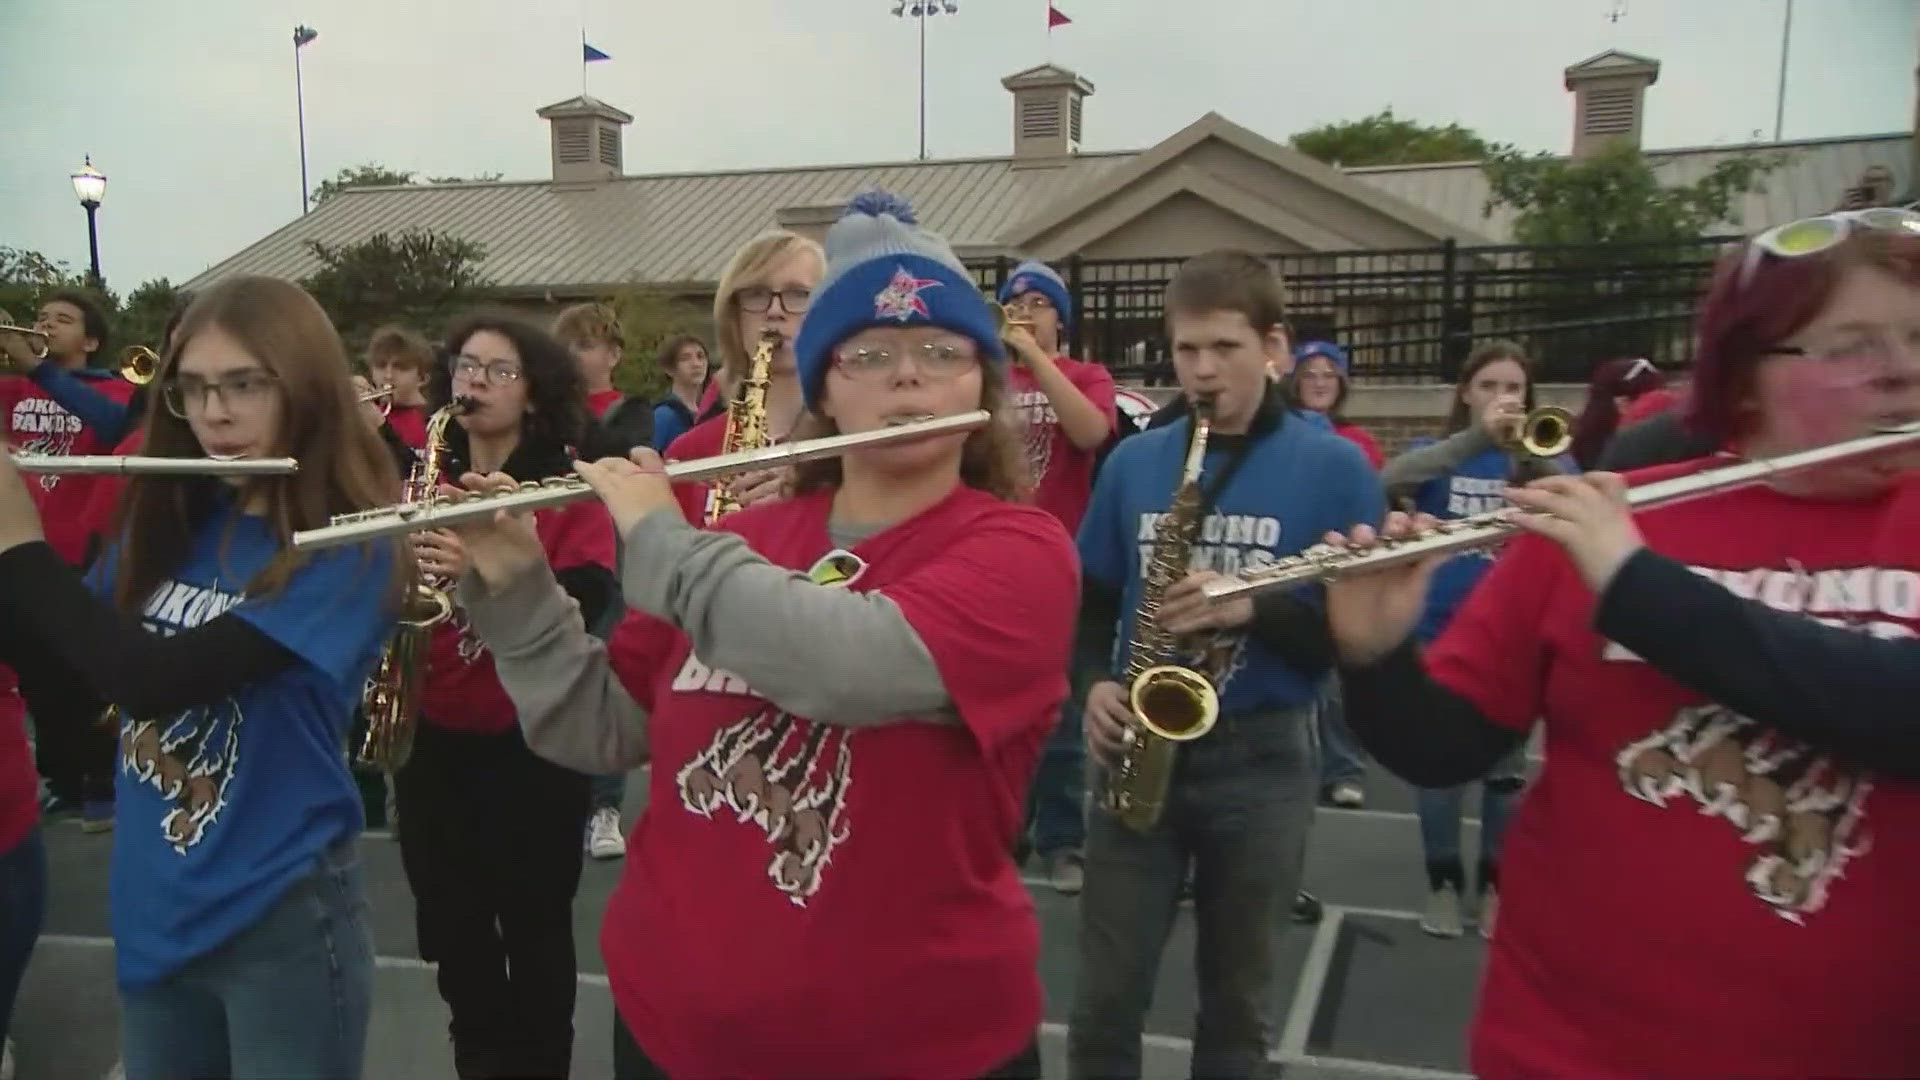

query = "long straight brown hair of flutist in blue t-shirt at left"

[{"left": 113, "top": 277, "right": 411, "bottom": 615}]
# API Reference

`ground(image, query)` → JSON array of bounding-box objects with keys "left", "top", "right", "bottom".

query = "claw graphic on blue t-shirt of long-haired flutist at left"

[{"left": 119, "top": 698, "right": 246, "bottom": 855}]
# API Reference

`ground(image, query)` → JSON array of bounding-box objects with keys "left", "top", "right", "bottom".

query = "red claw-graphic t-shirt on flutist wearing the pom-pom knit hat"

[{"left": 601, "top": 488, "right": 1079, "bottom": 1080}]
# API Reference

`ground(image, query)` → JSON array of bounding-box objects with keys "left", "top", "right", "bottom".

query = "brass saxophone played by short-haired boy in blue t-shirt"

[{"left": 1104, "top": 400, "right": 1219, "bottom": 832}]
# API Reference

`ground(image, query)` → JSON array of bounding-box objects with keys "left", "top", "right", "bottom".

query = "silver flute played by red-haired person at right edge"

[{"left": 1200, "top": 421, "right": 1920, "bottom": 601}]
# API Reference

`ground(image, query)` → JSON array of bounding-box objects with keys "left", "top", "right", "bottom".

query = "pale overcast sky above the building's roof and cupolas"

[{"left": 0, "top": 0, "right": 1920, "bottom": 294}]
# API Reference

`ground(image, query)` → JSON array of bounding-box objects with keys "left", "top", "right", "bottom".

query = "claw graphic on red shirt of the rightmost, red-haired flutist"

[{"left": 1615, "top": 705, "right": 1874, "bottom": 924}]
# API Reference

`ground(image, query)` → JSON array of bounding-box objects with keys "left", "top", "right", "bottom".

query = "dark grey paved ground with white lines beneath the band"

[{"left": 13, "top": 764, "right": 1482, "bottom": 1080}]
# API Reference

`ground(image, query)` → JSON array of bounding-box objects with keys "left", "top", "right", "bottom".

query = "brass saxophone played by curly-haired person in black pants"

[{"left": 355, "top": 398, "right": 472, "bottom": 773}]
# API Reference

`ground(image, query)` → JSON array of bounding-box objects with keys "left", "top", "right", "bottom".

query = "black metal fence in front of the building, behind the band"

[{"left": 972, "top": 236, "right": 1740, "bottom": 384}]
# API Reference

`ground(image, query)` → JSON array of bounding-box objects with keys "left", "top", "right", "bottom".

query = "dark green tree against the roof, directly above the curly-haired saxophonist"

[{"left": 301, "top": 229, "right": 486, "bottom": 343}]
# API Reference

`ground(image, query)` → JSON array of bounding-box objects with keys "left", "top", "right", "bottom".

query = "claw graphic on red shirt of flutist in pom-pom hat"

[{"left": 674, "top": 707, "right": 852, "bottom": 907}]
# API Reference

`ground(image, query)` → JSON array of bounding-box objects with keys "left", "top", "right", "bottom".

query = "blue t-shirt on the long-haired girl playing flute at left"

[{"left": 88, "top": 505, "right": 394, "bottom": 986}]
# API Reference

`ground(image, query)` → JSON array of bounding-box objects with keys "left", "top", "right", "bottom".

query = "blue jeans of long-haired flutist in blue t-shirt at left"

[{"left": 121, "top": 840, "right": 372, "bottom": 1080}]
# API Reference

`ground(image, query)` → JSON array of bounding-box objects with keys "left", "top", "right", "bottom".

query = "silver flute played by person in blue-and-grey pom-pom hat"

[{"left": 294, "top": 409, "right": 993, "bottom": 550}]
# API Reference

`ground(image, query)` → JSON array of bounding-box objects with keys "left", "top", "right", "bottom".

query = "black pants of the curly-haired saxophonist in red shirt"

[{"left": 394, "top": 723, "right": 588, "bottom": 1080}]
